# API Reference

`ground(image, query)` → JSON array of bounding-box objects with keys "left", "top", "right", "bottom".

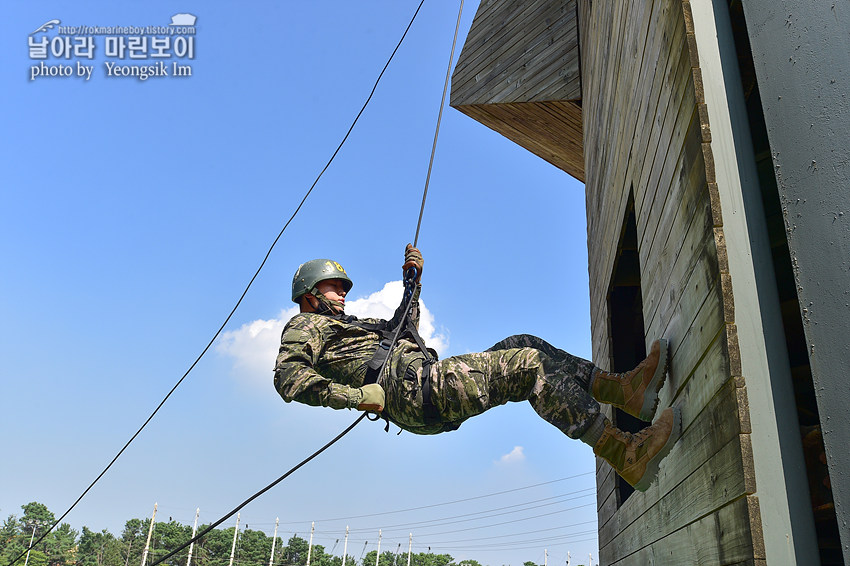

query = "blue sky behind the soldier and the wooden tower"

[{"left": 0, "top": 1, "right": 596, "bottom": 566}]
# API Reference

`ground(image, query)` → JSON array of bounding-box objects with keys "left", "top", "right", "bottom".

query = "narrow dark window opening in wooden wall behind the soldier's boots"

[{"left": 608, "top": 191, "right": 646, "bottom": 507}]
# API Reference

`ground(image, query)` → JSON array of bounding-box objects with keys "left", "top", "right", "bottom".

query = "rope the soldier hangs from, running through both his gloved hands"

[{"left": 144, "top": 4, "right": 463, "bottom": 566}]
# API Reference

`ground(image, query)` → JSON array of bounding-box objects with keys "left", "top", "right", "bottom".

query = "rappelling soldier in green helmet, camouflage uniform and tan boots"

[{"left": 274, "top": 244, "right": 680, "bottom": 491}]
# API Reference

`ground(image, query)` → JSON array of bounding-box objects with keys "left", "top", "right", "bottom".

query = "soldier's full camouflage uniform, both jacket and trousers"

[{"left": 275, "top": 288, "right": 599, "bottom": 438}]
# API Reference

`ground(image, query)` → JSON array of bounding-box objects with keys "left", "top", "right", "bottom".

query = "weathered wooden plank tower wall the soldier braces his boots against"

[{"left": 579, "top": 0, "right": 764, "bottom": 565}]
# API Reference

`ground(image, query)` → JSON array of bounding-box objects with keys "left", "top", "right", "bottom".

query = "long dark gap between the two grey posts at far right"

[{"left": 729, "top": 0, "right": 844, "bottom": 566}]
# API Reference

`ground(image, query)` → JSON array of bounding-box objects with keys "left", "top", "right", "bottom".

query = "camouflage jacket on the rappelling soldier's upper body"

[{"left": 274, "top": 286, "right": 424, "bottom": 409}]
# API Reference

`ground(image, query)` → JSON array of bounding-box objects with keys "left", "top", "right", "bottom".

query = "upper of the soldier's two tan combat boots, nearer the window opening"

[{"left": 591, "top": 339, "right": 667, "bottom": 421}]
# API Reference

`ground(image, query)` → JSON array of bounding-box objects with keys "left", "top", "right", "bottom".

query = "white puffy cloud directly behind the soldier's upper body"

[{"left": 216, "top": 281, "right": 448, "bottom": 389}]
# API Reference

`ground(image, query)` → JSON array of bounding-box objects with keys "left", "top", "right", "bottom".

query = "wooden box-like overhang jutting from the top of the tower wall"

[{"left": 451, "top": 0, "right": 584, "bottom": 182}]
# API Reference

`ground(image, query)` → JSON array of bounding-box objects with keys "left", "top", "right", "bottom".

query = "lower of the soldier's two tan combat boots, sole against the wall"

[{"left": 593, "top": 408, "right": 682, "bottom": 491}]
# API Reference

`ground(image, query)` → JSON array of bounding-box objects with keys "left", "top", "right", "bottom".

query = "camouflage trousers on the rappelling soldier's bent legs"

[{"left": 385, "top": 334, "right": 599, "bottom": 438}]
